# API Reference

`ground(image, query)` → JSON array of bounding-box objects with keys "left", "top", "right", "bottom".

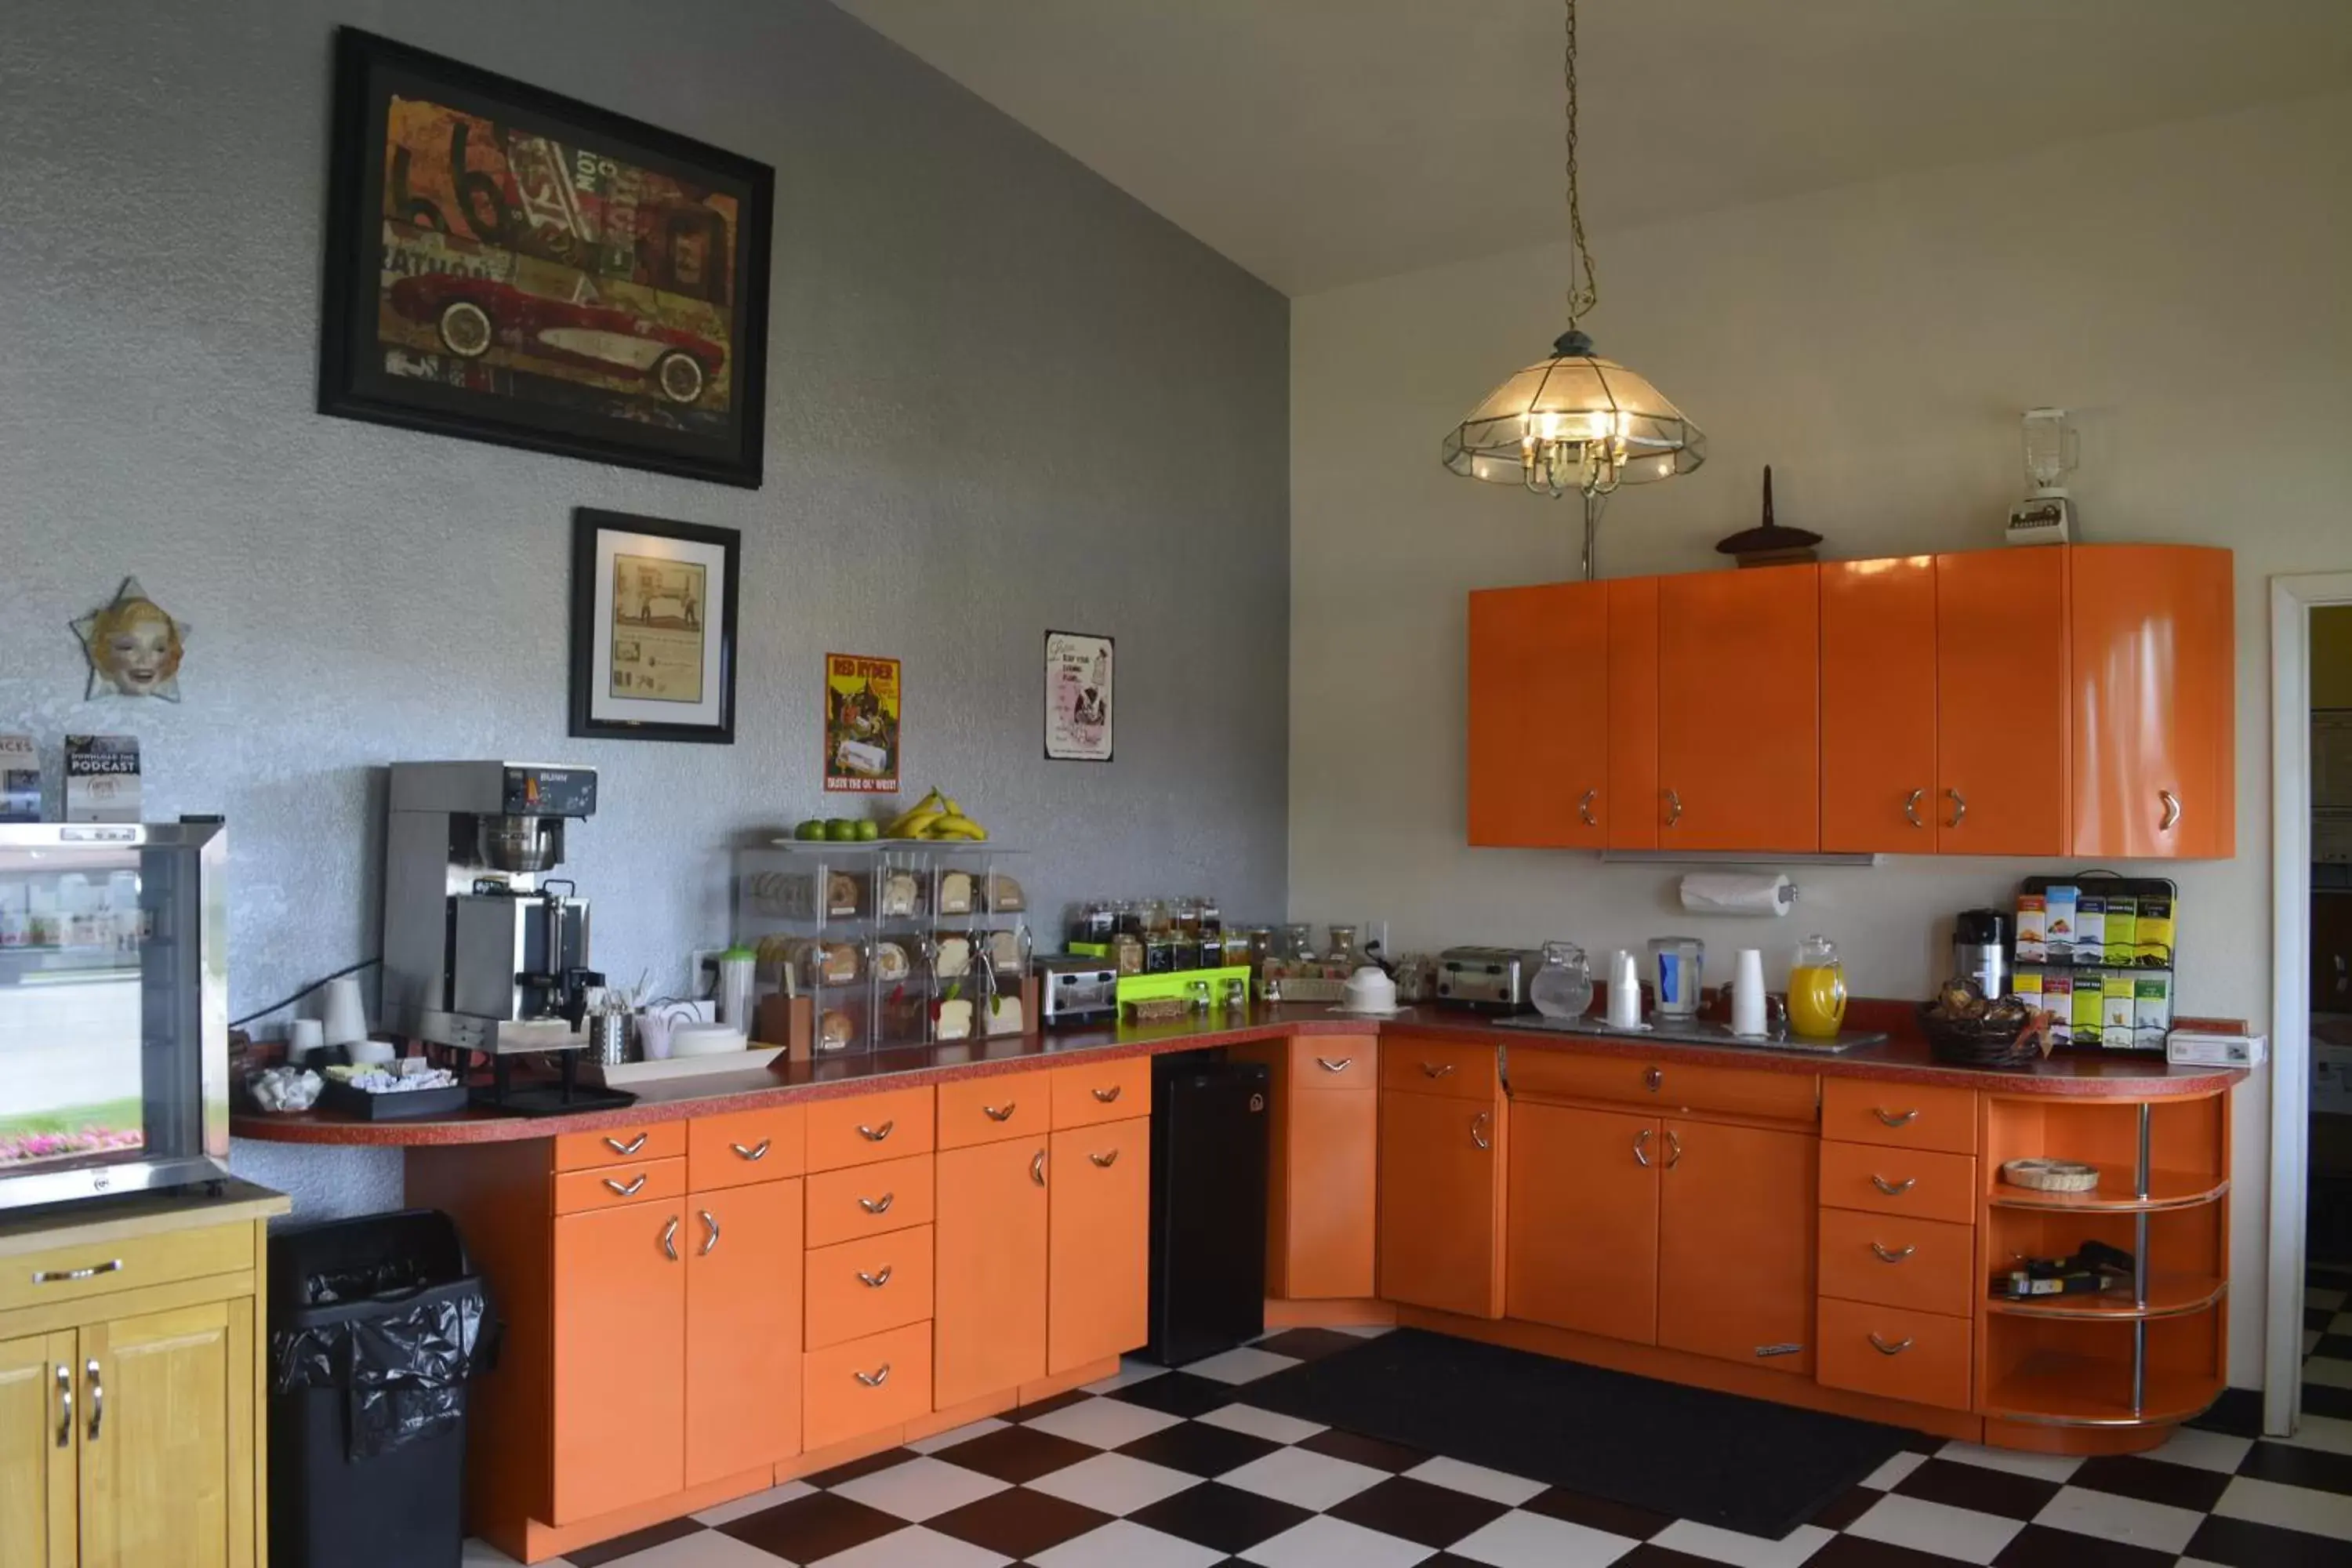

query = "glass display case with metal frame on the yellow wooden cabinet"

[{"left": 0, "top": 822, "right": 228, "bottom": 1208}]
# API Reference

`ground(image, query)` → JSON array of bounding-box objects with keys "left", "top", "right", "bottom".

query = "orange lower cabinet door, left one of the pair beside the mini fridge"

[{"left": 931, "top": 1142, "right": 1054, "bottom": 1410}]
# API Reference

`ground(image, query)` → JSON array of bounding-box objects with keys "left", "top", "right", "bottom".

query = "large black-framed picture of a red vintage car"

[{"left": 318, "top": 28, "right": 776, "bottom": 487}]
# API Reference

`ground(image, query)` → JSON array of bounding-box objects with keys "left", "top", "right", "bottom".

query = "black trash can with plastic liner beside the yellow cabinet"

[{"left": 268, "top": 1208, "right": 494, "bottom": 1568}]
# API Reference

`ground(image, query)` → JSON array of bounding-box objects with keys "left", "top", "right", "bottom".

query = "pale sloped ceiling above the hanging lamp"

[{"left": 835, "top": 0, "right": 2352, "bottom": 294}]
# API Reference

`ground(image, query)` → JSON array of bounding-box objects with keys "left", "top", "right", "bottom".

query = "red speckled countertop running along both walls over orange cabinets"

[{"left": 230, "top": 999, "right": 2246, "bottom": 1145}]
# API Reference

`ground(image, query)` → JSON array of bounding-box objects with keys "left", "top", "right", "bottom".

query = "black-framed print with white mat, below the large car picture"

[{"left": 572, "top": 508, "right": 743, "bottom": 746}]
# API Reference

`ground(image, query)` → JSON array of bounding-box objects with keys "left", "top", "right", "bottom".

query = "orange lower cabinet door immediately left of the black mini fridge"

[{"left": 1044, "top": 1116, "right": 1152, "bottom": 1373}]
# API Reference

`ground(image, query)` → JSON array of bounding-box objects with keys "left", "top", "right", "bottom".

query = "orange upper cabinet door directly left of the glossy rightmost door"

[{"left": 1929, "top": 548, "right": 2070, "bottom": 855}]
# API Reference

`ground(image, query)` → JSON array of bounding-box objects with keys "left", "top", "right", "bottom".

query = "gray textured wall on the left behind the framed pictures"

[{"left": 0, "top": 0, "right": 1289, "bottom": 1213}]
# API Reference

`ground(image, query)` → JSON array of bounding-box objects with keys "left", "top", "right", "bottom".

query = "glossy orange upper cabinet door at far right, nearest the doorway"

[{"left": 2067, "top": 546, "right": 2237, "bottom": 858}]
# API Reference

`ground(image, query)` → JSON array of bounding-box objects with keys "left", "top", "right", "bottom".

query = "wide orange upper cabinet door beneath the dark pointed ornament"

[{"left": 1656, "top": 567, "right": 1820, "bottom": 851}]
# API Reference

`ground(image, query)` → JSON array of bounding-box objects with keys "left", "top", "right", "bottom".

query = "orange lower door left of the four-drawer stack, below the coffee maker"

[{"left": 687, "top": 1180, "right": 802, "bottom": 1486}]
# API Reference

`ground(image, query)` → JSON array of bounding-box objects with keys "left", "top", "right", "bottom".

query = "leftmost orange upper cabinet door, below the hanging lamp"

[{"left": 1470, "top": 583, "right": 1611, "bottom": 848}]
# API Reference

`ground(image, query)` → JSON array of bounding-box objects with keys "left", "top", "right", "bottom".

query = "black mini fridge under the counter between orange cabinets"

[{"left": 1143, "top": 1051, "right": 1272, "bottom": 1366}]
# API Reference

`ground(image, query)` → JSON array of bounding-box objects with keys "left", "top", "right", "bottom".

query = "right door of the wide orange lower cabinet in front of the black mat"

[{"left": 1658, "top": 1116, "right": 1820, "bottom": 1373}]
